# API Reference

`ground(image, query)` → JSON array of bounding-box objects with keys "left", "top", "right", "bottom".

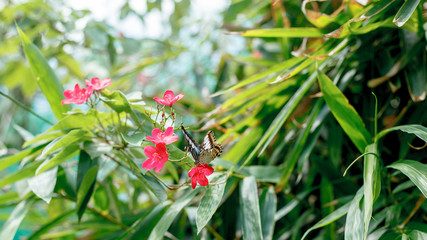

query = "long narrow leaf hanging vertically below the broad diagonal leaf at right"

[{"left": 363, "top": 143, "right": 381, "bottom": 239}]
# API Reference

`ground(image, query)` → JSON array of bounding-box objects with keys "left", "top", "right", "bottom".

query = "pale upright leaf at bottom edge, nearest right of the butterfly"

[{"left": 240, "top": 176, "right": 263, "bottom": 239}]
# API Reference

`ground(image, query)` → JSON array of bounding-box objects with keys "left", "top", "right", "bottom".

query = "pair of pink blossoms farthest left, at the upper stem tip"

[{"left": 61, "top": 78, "right": 111, "bottom": 104}]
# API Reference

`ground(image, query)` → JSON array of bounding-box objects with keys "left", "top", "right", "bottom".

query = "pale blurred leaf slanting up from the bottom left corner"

[{"left": 0, "top": 199, "right": 34, "bottom": 240}]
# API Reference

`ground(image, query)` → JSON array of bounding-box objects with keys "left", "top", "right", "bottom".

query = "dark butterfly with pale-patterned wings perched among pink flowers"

[{"left": 181, "top": 125, "right": 222, "bottom": 165}]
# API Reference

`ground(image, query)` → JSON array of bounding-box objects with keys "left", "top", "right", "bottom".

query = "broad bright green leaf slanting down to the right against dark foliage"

[{"left": 317, "top": 68, "right": 372, "bottom": 152}]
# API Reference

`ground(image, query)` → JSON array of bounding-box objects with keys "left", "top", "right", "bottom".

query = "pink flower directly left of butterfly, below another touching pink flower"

[{"left": 142, "top": 143, "right": 169, "bottom": 172}]
